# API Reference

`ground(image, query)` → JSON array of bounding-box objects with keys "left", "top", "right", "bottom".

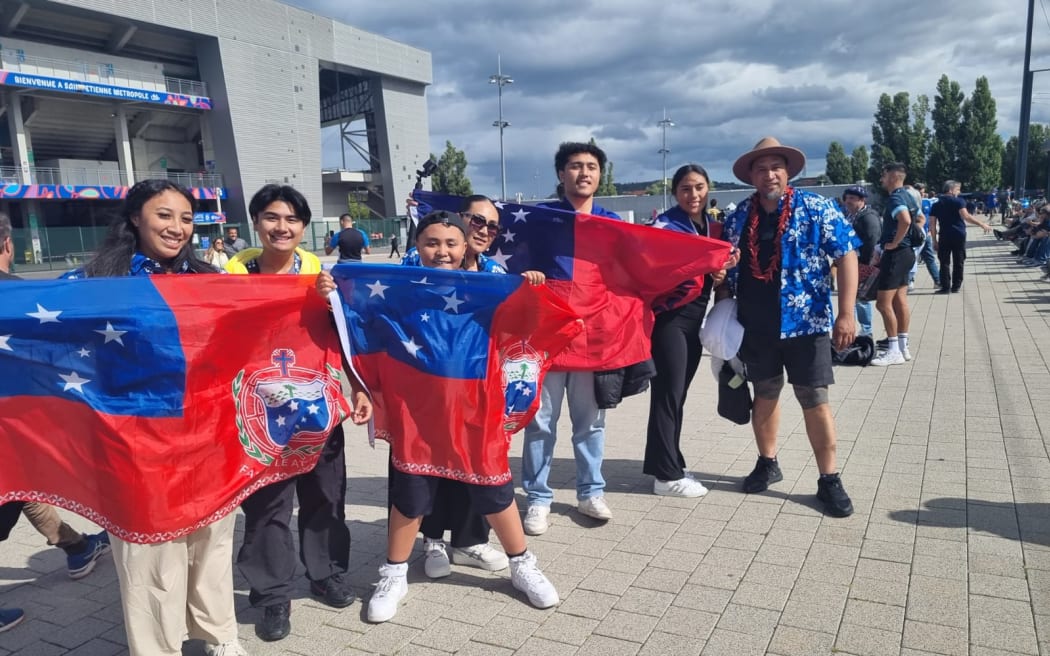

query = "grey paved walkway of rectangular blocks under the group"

[{"left": 0, "top": 228, "right": 1050, "bottom": 656}]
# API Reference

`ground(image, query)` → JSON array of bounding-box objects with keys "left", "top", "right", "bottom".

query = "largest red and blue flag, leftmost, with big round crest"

[{"left": 0, "top": 275, "right": 349, "bottom": 544}]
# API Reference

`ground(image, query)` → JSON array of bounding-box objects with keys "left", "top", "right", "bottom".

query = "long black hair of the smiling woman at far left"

[{"left": 84, "top": 179, "right": 215, "bottom": 278}]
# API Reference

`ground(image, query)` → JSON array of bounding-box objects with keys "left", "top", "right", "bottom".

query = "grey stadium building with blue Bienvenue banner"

[{"left": 0, "top": 0, "right": 432, "bottom": 271}]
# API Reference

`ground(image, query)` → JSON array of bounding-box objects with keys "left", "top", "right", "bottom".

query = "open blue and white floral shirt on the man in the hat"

[{"left": 722, "top": 189, "right": 860, "bottom": 339}]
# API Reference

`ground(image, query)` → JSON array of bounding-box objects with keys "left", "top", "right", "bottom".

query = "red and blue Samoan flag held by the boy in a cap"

[{"left": 332, "top": 264, "right": 582, "bottom": 485}]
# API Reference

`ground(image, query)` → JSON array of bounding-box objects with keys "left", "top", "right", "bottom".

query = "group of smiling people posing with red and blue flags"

[{"left": 0, "top": 137, "right": 881, "bottom": 656}]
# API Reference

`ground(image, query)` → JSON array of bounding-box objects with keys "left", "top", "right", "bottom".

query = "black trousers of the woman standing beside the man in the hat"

[{"left": 642, "top": 306, "right": 704, "bottom": 481}]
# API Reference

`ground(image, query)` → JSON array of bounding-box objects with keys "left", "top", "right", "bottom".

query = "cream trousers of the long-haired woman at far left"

[{"left": 110, "top": 513, "right": 237, "bottom": 656}]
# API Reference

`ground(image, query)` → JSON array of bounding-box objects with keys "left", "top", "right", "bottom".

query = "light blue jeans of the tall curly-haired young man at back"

[{"left": 522, "top": 372, "right": 605, "bottom": 506}]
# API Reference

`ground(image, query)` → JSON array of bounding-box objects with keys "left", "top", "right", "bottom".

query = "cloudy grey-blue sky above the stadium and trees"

[{"left": 290, "top": 0, "right": 1050, "bottom": 197}]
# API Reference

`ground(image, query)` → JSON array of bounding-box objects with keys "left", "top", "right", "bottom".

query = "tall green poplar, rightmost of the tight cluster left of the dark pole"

[{"left": 959, "top": 77, "right": 1003, "bottom": 191}]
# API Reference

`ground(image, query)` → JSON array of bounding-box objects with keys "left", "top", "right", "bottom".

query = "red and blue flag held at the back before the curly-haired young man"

[{"left": 414, "top": 191, "right": 732, "bottom": 371}]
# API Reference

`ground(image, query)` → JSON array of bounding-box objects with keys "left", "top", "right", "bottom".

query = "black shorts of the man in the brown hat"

[{"left": 739, "top": 331, "right": 835, "bottom": 387}]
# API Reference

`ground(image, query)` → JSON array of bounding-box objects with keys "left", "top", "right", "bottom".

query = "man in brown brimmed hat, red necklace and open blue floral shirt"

[{"left": 725, "top": 136, "right": 860, "bottom": 517}]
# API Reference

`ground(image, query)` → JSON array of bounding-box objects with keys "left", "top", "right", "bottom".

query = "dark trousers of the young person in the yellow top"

[{"left": 237, "top": 425, "right": 350, "bottom": 607}]
